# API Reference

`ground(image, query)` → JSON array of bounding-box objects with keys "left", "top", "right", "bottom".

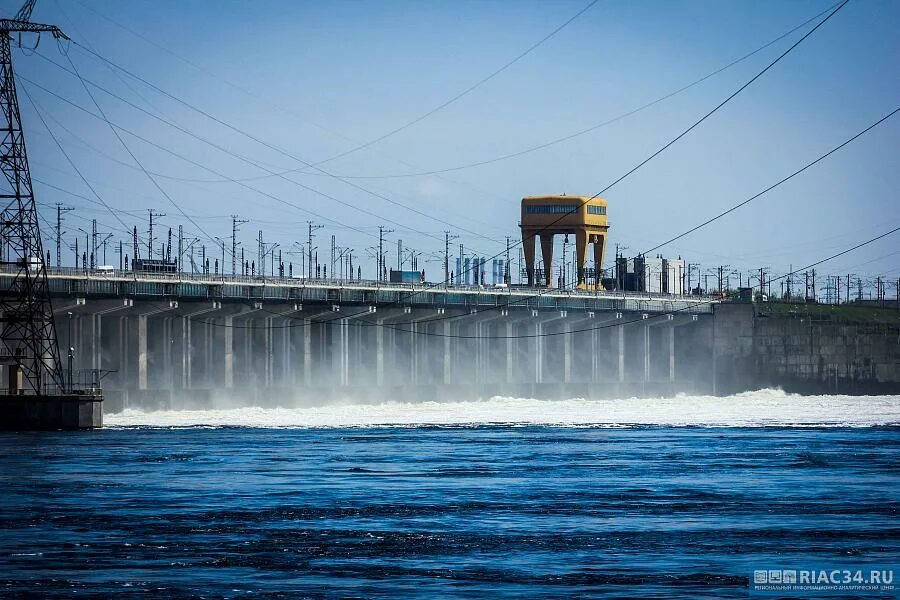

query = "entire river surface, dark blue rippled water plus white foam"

[{"left": 0, "top": 390, "right": 900, "bottom": 598}]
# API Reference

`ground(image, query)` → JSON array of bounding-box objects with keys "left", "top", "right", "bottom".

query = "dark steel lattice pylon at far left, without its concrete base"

[{"left": 0, "top": 0, "right": 67, "bottom": 394}]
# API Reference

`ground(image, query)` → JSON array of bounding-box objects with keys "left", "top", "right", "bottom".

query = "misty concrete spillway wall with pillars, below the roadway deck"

[{"left": 57, "top": 299, "right": 713, "bottom": 412}]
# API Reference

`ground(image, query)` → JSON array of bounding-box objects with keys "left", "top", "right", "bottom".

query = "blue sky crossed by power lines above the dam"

[{"left": 4, "top": 0, "right": 900, "bottom": 290}]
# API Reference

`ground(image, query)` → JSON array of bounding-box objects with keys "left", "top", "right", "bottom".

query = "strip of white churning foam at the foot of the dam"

[{"left": 104, "top": 389, "right": 900, "bottom": 428}]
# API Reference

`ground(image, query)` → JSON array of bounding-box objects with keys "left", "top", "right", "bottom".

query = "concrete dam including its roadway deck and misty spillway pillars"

[{"left": 0, "top": 269, "right": 715, "bottom": 412}]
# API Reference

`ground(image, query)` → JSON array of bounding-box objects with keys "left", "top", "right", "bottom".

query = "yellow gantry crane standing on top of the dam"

[{"left": 519, "top": 194, "right": 609, "bottom": 290}]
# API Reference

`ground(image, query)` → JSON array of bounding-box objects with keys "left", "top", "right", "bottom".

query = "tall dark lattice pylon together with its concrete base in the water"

[{"left": 0, "top": 0, "right": 103, "bottom": 429}]
